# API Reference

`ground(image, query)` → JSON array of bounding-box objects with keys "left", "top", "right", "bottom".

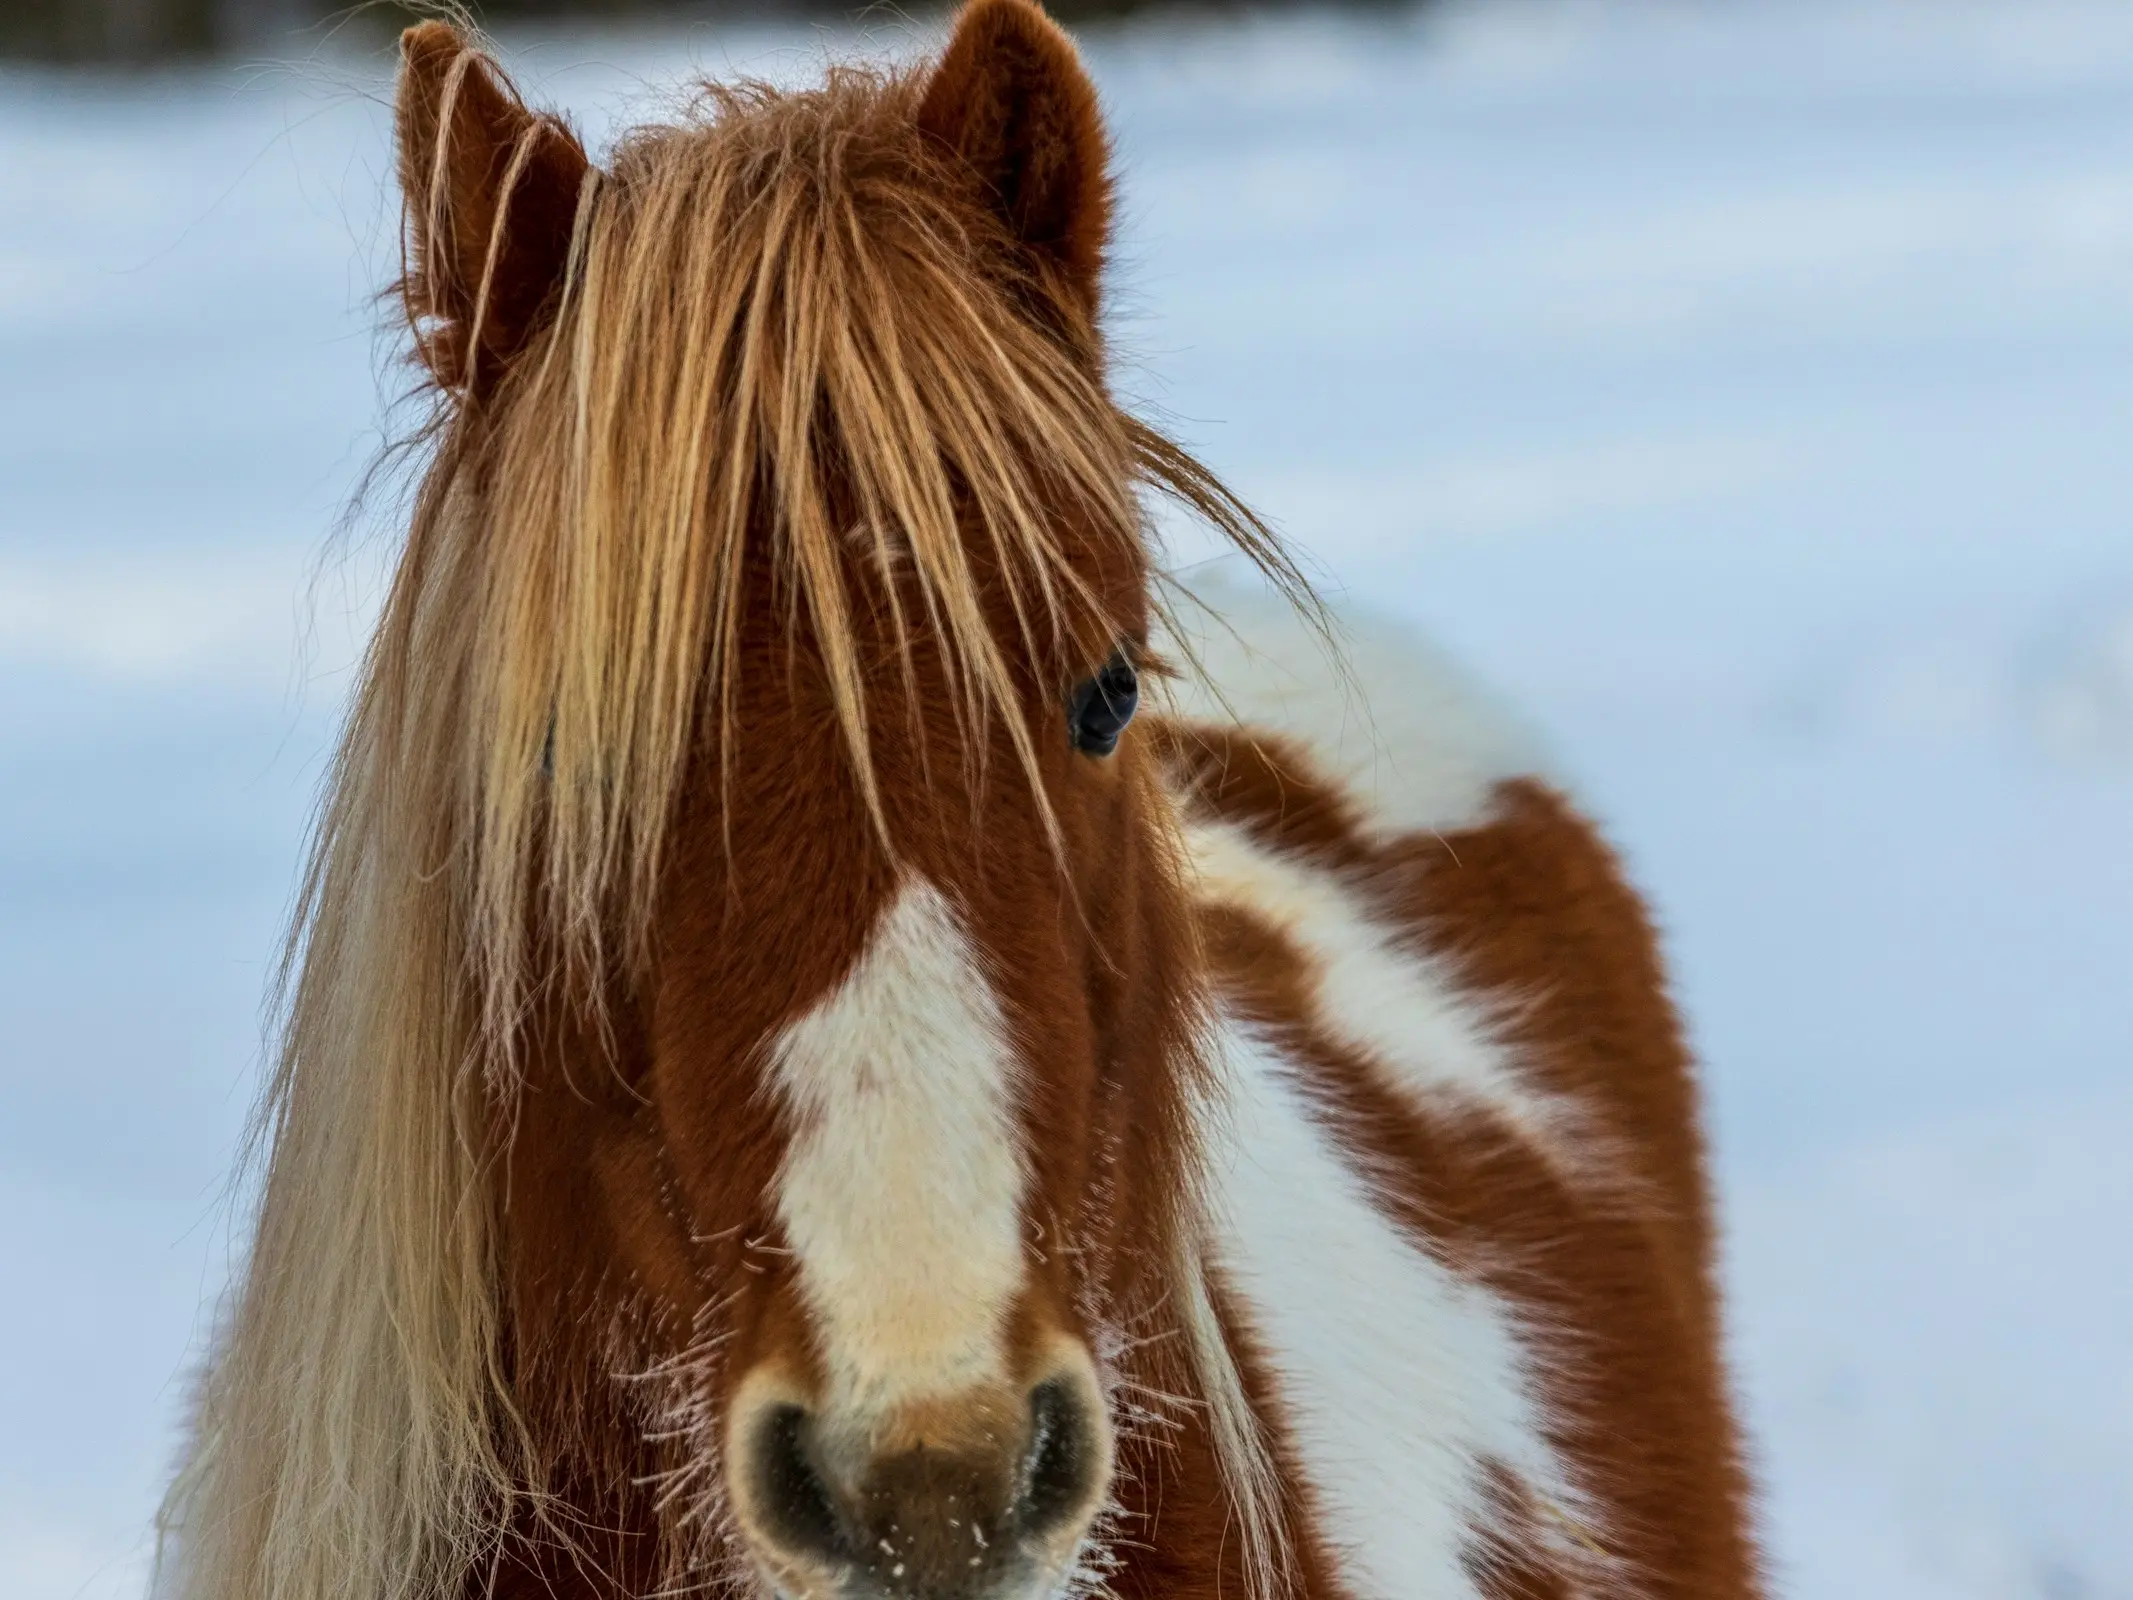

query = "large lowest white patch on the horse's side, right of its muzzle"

[{"left": 1209, "top": 1020, "right": 1604, "bottom": 1600}]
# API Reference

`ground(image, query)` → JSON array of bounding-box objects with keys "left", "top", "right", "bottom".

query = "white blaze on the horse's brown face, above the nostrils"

[{"left": 770, "top": 881, "right": 1026, "bottom": 1421}]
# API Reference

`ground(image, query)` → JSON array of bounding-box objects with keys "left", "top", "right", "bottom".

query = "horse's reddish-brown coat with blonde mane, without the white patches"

[{"left": 171, "top": 0, "right": 1753, "bottom": 1600}]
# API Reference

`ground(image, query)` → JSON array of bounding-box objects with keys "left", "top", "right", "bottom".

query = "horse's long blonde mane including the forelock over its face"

[{"left": 160, "top": 43, "right": 1290, "bottom": 1600}]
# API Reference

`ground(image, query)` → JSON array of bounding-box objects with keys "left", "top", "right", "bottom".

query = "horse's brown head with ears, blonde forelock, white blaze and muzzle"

[{"left": 388, "top": 0, "right": 1271, "bottom": 1600}]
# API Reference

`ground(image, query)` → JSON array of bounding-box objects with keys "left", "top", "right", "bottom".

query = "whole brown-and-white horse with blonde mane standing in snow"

[{"left": 158, "top": 0, "right": 1760, "bottom": 1600}]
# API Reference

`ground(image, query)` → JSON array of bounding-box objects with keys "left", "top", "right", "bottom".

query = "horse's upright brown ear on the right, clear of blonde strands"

[{"left": 919, "top": 0, "right": 1111, "bottom": 314}]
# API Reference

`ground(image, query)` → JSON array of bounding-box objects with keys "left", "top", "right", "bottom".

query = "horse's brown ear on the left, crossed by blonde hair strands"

[{"left": 397, "top": 21, "right": 591, "bottom": 390}]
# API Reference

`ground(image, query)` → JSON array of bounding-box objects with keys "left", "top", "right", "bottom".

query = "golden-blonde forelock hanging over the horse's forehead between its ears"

[{"left": 442, "top": 59, "right": 1150, "bottom": 1041}]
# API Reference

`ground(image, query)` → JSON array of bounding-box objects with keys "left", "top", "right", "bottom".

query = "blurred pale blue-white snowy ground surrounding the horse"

[{"left": 0, "top": 0, "right": 2133, "bottom": 1600}]
